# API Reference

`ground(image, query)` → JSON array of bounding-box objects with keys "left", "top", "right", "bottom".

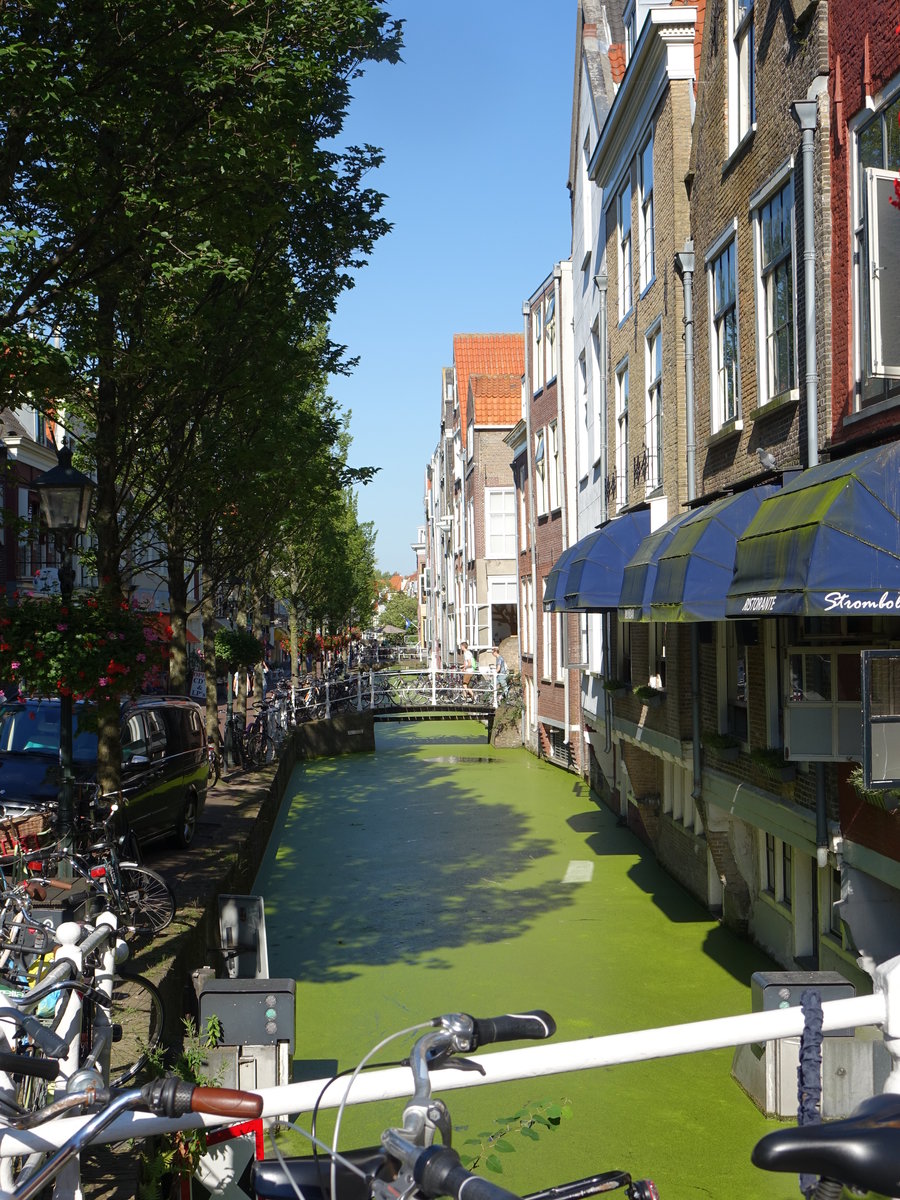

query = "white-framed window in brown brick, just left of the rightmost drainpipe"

[{"left": 751, "top": 168, "right": 799, "bottom": 406}]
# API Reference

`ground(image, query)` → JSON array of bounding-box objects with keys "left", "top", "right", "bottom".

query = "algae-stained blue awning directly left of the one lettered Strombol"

[{"left": 650, "top": 484, "right": 780, "bottom": 622}]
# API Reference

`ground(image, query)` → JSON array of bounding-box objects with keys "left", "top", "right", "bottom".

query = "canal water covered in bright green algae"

[{"left": 256, "top": 722, "right": 798, "bottom": 1200}]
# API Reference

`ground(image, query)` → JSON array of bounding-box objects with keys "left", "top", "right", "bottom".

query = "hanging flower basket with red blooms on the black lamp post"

[{"left": 0, "top": 593, "right": 172, "bottom": 700}]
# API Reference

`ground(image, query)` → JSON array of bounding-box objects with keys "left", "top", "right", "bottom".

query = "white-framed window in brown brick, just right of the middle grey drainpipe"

[{"left": 707, "top": 222, "right": 743, "bottom": 433}]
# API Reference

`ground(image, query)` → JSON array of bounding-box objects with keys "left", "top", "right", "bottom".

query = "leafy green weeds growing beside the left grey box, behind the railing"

[{"left": 138, "top": 1014, "right": 222, "bottom": 1200}]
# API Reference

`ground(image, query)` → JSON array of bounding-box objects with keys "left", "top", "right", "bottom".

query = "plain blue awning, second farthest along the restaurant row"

[{"left": 565, "top": 509, "right": 650, "bottom": 612}]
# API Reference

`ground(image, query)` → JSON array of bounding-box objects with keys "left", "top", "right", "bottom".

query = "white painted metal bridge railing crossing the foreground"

[{"left": 7, "top": 958, "right": 900, "bottom": 1157}]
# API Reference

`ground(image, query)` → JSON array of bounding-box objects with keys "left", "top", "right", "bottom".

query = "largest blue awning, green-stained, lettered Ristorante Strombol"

[{"left": 726, "top": 442, "right": 900, "bottom": 617}]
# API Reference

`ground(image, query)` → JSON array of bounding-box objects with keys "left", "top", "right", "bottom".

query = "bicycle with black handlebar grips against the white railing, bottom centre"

[{"left": 251, "top": 1010, "right": 659, "bottom": 1200}]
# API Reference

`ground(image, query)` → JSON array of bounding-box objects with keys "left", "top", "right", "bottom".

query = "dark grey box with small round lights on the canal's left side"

[{"left": 199, "top": 979, "right": 296, "bottom": 1054}]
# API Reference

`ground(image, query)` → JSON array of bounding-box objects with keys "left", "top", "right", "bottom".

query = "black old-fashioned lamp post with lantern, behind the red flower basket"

[{"left": 34, "top": 444, "right": 94, "bottom": 850}]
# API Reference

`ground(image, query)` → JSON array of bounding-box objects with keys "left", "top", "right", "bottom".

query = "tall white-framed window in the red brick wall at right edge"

[{"left": 852, "top": 90, "right": 900, "bottom": 398}]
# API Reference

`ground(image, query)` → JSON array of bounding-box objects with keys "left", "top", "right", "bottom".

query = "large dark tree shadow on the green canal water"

[{"left": 256, "top": 720, "right": 585, "bottom": 982}]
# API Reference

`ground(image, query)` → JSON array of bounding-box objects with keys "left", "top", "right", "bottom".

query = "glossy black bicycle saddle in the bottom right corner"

[{"left": 750, "top": 1093, "right": 900, "bottom": 1196}]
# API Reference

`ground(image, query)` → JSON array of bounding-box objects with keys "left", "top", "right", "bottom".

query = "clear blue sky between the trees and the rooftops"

[{"left": 330, "top": 0, "right": 576, "bottom": 574}]
